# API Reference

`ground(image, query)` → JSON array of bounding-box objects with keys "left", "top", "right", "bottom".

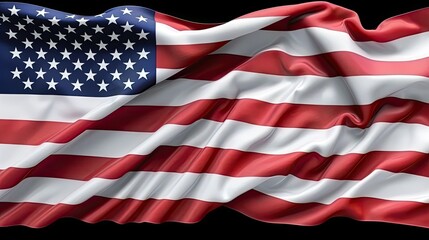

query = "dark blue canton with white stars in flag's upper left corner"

[{"left": 0, "top": 3, "right": 156, "bottom": 97}]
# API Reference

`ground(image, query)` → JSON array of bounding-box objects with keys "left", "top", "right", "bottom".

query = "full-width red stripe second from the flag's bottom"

[{"left": 0, "top": 146, "right": 429, "bottom": 189}]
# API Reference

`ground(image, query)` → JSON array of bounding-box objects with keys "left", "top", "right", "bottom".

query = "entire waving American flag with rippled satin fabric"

[{"left": 0, "top": 2, "right": 429, "bottom": 227}]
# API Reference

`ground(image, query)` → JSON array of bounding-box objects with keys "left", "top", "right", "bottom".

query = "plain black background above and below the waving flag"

[{"left": 0, "top": 0, "right": 429, "bottom": 240}]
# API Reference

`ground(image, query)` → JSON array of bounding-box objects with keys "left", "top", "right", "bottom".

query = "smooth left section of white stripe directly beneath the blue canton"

[{"left": 0, "top": 94, "right": 135, "bottom": 122}]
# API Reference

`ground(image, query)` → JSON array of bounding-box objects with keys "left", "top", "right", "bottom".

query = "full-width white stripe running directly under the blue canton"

[{"left": 0, "top": 71, "right": 429, "bottom": 122}]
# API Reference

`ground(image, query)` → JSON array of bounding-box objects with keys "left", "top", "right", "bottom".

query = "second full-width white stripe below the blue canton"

[{"left": 0, "top": 120, "right": 429, "bottom": 169}]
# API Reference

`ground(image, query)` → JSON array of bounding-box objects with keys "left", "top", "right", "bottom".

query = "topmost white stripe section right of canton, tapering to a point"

[{"left": 155, "top": 17, "right": 285, "bottom": 45}]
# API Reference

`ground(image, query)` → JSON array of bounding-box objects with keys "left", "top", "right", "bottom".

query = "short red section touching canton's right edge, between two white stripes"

[{"left": 156, "top": 42, "right": 226, "bottom": 69}]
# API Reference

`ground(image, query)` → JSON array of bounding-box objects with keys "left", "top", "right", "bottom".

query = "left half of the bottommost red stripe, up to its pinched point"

[{"left": 0, "top": 197, "right": 220, "bottom": 228}]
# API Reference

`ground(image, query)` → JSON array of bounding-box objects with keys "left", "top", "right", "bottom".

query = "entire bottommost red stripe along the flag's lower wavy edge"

[{"left": 0, "top": 191, "right": 429, "bottom": 228}]
